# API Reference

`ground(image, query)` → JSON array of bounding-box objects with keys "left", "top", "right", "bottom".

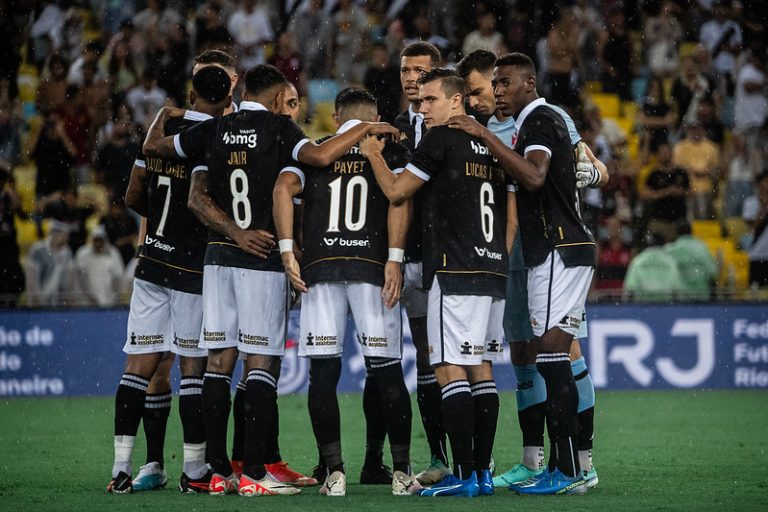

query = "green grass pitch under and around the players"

[{"left": 0, "top": 391, "right": 768, "bottom": 512}]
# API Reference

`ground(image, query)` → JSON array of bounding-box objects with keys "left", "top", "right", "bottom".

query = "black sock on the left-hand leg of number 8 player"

[{"left": 202, "top": 372, "right": 232, "bottom": 476}]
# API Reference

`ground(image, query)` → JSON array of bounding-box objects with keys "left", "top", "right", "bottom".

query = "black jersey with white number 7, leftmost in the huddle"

[{"left": 135, "top": 111, "right": 211, "bottom": 294}]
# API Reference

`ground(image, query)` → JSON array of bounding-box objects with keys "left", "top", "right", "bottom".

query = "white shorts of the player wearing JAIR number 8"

[{"left": 202, "top": 265, "right": 290, "bottom": 356}]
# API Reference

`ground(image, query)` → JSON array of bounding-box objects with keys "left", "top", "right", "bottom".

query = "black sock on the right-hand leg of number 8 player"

[{"left": 243, "top": 368, "right": 277, "bottom": 480}]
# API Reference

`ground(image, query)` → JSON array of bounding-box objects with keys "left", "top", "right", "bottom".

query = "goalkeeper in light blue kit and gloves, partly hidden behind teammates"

[{"left": 449, "top": 50, "right": 608, "bottom": 487}]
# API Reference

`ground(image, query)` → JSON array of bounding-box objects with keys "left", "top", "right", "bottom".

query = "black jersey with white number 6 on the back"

[{"left": 406, "top": 126, "right": 511, "bottom": 298}]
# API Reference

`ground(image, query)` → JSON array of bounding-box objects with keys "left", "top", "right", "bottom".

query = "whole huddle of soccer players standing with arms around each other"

[{"left": 108, "top": 42, "right": 608, "bottom": 497}]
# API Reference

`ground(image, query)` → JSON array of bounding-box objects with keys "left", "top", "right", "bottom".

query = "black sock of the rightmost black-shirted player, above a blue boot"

[{"left": 536, "top": 353, "right": 580, "bottom": 477}]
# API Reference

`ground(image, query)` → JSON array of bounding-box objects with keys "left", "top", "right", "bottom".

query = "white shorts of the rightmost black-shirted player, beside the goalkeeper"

[{"left": 528, "top": 251, "right": 595, "bottom": 336}]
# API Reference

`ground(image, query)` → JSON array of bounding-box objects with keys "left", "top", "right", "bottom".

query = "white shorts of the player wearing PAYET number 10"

[{"left": 299, "top": 281, "right": 403, "bottom": 359}]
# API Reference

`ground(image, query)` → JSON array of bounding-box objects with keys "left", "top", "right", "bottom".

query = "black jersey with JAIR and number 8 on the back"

[{"left": 174, "top": 101, "right": 309, "bottom": 272}]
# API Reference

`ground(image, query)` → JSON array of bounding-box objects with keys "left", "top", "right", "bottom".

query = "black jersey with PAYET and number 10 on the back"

[{"left": 302, "top": 121, "right": 410, "bottom": 286}]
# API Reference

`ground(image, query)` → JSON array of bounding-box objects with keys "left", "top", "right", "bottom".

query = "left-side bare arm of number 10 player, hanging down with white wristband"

[{"left": 272, "top": 167, "right": 307, "bottom": 292}]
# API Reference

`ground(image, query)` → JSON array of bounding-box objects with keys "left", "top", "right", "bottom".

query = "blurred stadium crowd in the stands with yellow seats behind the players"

[{"left": 0, "top": 0, "right": 768, "bottom": 306}]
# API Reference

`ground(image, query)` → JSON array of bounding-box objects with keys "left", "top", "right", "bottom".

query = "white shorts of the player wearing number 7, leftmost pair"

[{"left": 123, "top": 279, "right": 208, "bottom": 357}]
